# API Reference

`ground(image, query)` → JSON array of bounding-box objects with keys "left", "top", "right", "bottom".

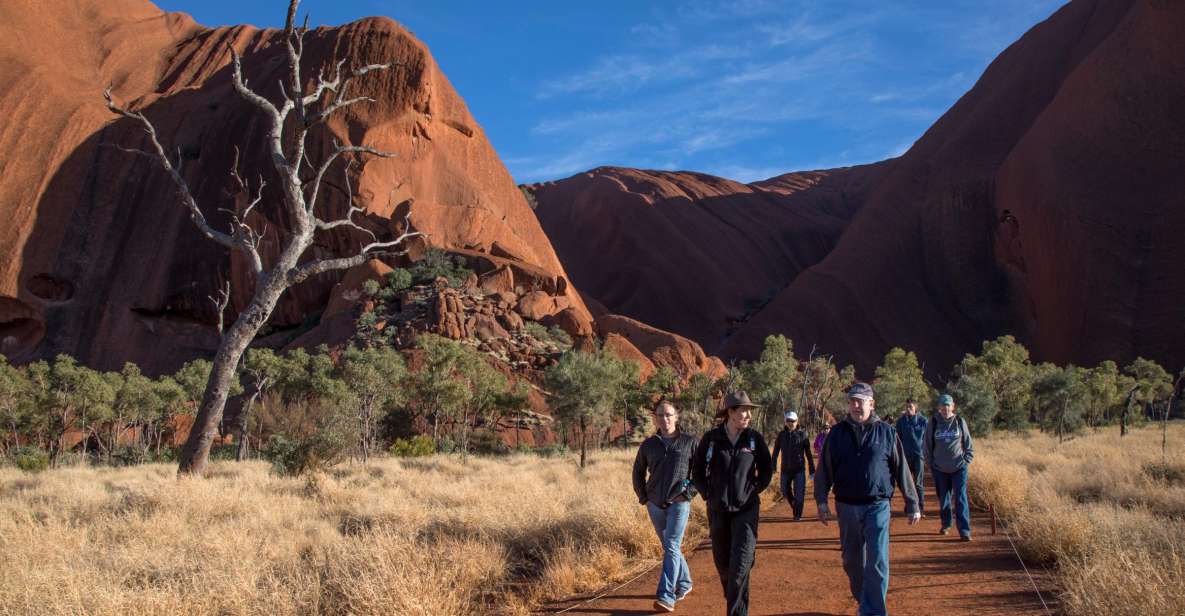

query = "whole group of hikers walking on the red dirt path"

[{"left": 633, "top": 383, "right": 974, "bottom": 616}]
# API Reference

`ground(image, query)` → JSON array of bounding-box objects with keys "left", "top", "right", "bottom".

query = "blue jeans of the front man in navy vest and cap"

[{"left": 835, "top": 500, "right": 889, "bottom": 616}]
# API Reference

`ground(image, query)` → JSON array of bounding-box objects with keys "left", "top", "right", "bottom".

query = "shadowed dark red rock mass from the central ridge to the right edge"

[{"left": 532, "top": 0, "right": 1185, "bottom": 377}]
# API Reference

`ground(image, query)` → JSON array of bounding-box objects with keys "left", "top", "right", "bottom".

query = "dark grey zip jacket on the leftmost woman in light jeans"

[{"left": 634, "top": 432, "right": 696, "bottom": 508}]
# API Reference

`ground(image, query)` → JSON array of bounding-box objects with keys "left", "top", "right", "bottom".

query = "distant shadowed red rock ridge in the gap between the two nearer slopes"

[{"left": 527, "top": 166, "right": 880, "bottom": 348}]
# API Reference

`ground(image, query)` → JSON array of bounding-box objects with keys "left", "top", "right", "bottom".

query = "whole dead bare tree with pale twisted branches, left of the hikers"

[{"left": 103, "top": 0, "right": 419, "bottom": 475}]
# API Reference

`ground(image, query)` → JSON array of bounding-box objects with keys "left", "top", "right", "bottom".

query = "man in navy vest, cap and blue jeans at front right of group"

[{"left": 815, "top": 383, "right": 922, "bottom": 616}]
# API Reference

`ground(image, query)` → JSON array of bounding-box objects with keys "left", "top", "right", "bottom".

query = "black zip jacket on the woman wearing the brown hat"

[{"left": 691, "top": 425, "right": 774, "bottom": 512}]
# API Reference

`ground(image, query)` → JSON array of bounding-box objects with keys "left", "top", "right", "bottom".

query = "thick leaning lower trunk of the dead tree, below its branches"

[{"left": 177, "top": 272, "right": 290, "bottom": 475}]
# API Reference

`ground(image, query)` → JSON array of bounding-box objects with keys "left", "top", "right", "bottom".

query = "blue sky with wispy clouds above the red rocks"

[{"left": 156, "top": 0, "right": 1064, "bottom": 182}]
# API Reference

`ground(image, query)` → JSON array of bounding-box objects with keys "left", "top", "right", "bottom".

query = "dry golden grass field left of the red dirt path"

[{"left": 0, "top": 451, "right": 705, "bottom": 616}]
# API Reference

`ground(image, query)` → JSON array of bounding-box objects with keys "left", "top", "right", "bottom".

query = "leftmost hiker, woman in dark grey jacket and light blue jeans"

[{"left": 634, "top": 399, "right": 697, "bottom": 611}]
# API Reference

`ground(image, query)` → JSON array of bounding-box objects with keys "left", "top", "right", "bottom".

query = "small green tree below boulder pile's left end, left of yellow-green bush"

[{"left": 340, "top": 346, "right": 408, "bottom": 464}]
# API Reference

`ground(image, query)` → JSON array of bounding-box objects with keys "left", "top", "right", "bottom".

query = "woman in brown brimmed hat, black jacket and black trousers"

[{"left": 691, "top": 391, "right": 774, "bottom": 616}]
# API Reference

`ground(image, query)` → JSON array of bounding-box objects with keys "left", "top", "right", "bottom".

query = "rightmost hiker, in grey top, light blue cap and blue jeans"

[{"left": 923, "top": 393, "right": 975, "bottom": 541}]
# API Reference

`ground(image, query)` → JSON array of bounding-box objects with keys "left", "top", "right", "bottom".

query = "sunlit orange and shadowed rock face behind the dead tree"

[{"left": 0, "top": 0, "right": 584, "bottom": 372}]
